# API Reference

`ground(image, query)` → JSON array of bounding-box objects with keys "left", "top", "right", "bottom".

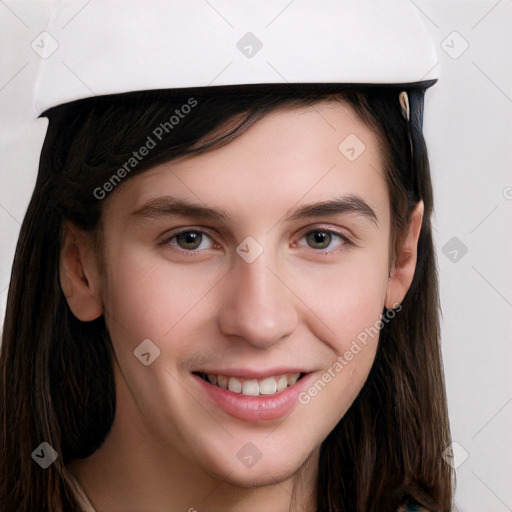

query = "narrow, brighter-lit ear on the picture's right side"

[{"left": 385, "top": 201, "right": 425, "bottom": 309}]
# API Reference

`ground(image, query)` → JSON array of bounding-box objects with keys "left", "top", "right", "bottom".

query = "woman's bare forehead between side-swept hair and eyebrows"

[{"left": 108, "top": 101, "right": 388, "bottom": 226}]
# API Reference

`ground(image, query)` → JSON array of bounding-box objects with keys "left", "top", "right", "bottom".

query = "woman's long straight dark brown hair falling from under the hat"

[{"left": 0, "top": 85, "right": 453, "bottom": 512}]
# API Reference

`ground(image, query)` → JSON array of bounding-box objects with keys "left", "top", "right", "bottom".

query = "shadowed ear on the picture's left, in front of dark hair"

[{"left": 59, "top": 222, "right": 103, "bottom": 322}]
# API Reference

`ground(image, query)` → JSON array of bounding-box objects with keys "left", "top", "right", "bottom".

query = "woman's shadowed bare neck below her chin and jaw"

[{"left": 70, "top": 372, "right": 319, "bottom": 512}]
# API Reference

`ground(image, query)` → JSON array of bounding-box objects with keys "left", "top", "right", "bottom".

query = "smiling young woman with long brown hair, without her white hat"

[{"left": 0, "top": 1, "right": 452, "bottom": 512}]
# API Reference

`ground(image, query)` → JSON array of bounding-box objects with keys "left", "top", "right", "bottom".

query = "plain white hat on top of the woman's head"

[{"left": 33, "top": 0, "right": 438, "bottom": 114}]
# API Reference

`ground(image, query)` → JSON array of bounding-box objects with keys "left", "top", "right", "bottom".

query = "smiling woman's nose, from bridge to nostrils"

[{"left": 218, "top": 253, "right": 298, "bottom": 349}]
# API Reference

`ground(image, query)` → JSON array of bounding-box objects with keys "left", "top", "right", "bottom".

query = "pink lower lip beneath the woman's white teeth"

[{"left": 193, "top": 373, "right": 314, "bottom": 421}]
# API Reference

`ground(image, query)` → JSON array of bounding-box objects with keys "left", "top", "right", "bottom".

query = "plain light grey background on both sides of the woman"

[{"left": 0, "top": 0, "right": 512, "bottom": 512}]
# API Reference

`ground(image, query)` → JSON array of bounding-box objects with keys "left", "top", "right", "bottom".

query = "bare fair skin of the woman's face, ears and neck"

[{"left": 60, "top": 102, "right": 423, "bottom": 512}]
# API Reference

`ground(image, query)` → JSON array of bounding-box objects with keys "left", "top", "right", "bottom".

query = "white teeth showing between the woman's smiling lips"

[{"left": 194, "top": 372, "right": 307, "bottom": 396}]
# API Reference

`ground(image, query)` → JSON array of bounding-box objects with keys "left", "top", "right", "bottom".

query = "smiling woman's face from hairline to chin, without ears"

[{"left": 92, "top": 102, "right": 390, "bottom": 486}]
